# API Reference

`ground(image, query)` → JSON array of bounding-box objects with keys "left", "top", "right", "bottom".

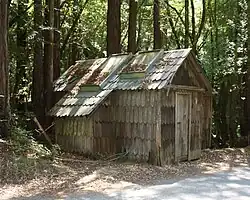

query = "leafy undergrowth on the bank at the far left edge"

[{"left": 0, "top": 121, "right": 59, "bottom": 184}]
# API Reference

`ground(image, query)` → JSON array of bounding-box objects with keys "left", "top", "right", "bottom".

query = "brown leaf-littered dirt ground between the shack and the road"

[{"left": 0, "top": 147, "right": 250, "bottom": 199}]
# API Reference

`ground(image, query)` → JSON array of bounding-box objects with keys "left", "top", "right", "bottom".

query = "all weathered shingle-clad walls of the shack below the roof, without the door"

[{"left": 55, "top": 90, "right": 212, "bottom": 164}]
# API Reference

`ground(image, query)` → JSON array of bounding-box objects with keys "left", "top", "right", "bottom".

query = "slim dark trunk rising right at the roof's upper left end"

[{"left": 53, "top": 0, "right": 61, "bottom": 80}]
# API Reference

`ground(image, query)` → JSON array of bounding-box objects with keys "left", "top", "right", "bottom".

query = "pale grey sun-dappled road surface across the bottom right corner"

[{"left": 14, "top": 167, "right": 250, "bottom": 200}]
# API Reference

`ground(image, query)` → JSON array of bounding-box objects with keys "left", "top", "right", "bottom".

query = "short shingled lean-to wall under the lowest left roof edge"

[{"left": 55, "top": 117, "right": 93, "bottom": 154}]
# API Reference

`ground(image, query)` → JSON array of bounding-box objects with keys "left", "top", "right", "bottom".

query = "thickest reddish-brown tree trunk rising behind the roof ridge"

[{"left": 107, "top": 0, "right": 121, "bottom": 55}]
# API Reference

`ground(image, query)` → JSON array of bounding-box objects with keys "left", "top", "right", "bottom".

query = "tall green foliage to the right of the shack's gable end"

[{"left": 200, "top": 0, "right": 248, "bottom": 146}]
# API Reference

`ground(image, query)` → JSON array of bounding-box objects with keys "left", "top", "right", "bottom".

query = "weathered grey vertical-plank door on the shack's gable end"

[{"left": 175, "top": 93, "right": 191, "bottom": 161}]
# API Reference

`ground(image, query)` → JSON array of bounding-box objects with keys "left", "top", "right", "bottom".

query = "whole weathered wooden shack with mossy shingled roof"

[{"left": 50, "top": 49, "right": 212, "bottom": 165}]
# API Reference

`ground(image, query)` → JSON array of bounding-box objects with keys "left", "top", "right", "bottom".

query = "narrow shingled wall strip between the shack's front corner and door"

[{"left": 161, "top": 90, "right": 175, "bottom": 164}]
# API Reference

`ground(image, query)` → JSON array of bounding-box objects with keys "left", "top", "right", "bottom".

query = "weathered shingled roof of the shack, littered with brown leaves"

[{"left": 49, "top": 49, "right": 211, "bottom": 117}]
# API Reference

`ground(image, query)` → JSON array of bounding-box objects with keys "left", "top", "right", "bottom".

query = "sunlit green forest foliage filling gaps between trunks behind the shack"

[{"left": 6, "top": 0, "right": 248, "bottom": 147}]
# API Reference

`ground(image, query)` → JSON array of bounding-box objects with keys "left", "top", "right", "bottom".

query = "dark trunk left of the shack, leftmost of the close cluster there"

[{"left": 32, "top": 0, "right": 45, "bottom": 124}]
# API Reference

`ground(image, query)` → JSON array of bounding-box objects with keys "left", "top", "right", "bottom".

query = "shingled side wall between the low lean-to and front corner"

[{"left": 94, "top": 90, "right": 159, "bottom": 161}]
